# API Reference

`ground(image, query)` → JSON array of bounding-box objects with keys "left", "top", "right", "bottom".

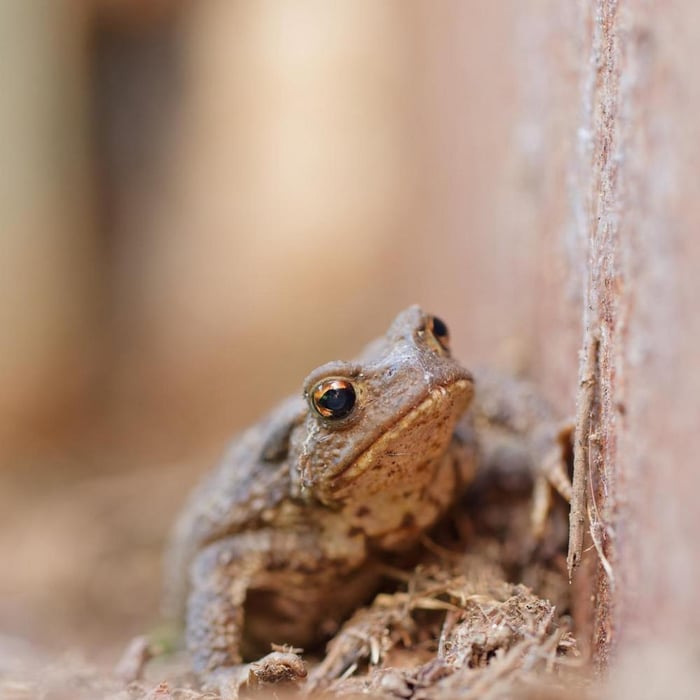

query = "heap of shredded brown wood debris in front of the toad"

[{"left": 310, "top": 555, "right": 579, "bottom": 700}]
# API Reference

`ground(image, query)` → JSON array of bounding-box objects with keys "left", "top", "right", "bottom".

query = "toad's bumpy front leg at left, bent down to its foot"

[{"left": 186, "top": 532, "right": 306, "bottom": 699}]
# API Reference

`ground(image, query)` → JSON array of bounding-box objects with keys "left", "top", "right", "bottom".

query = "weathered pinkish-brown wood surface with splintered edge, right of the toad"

[{"left": 524, "top": 0, "right": 700, "bottom": 667}]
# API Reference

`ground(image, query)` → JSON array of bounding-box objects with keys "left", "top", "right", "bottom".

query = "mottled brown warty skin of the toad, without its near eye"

[{"left": 166, "top": 306, "right": 566, "bottom": 696}]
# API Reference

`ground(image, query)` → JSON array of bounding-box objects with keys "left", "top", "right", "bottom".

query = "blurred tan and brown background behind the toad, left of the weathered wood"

[{"left": 0, "top": 0, "right": 581, "bottom": 660}]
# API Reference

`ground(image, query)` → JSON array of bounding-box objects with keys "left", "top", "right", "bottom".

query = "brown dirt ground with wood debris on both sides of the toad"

[{"left": 0, "top": 454, "right": 590, "bottom": 700}]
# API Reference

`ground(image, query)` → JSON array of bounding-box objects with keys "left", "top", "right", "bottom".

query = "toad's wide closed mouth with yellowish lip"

[{"left": 327, "top": 379, "right": 474, "bottom": 485}]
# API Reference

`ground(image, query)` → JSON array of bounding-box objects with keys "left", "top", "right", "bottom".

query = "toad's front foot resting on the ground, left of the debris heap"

[{"left": 204, "top": 651, "right": 306, "bottom": 700}]
